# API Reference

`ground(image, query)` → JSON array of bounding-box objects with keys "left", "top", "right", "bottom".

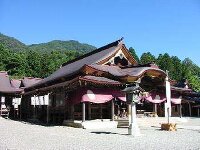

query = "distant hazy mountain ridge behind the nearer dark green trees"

[{"left": 0, "top": 33, "right": 96, "bottom": 53}]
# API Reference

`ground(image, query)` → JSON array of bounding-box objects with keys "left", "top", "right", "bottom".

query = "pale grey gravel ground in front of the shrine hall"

[{"left": 0, "top": 117, "right": 200, "bottom": 150}]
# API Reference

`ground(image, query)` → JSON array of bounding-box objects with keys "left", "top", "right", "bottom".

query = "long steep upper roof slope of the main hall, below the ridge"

[{"left": 26, "top": 39, "right": 122, "bottom": 87}]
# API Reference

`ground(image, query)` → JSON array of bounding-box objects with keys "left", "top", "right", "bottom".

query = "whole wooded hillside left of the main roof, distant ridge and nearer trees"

[{"left": 0, "top": 34, "right": 95, "bottom": 78}]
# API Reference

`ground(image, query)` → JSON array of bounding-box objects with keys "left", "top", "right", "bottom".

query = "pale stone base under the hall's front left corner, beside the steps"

[{"left": 63, "top": 119, "right": 118, "bottom": 129}]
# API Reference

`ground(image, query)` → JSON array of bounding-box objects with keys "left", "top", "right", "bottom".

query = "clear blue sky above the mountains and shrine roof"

[{"left": 0, "top": 0, "right": 200, "bottom": 66}]
